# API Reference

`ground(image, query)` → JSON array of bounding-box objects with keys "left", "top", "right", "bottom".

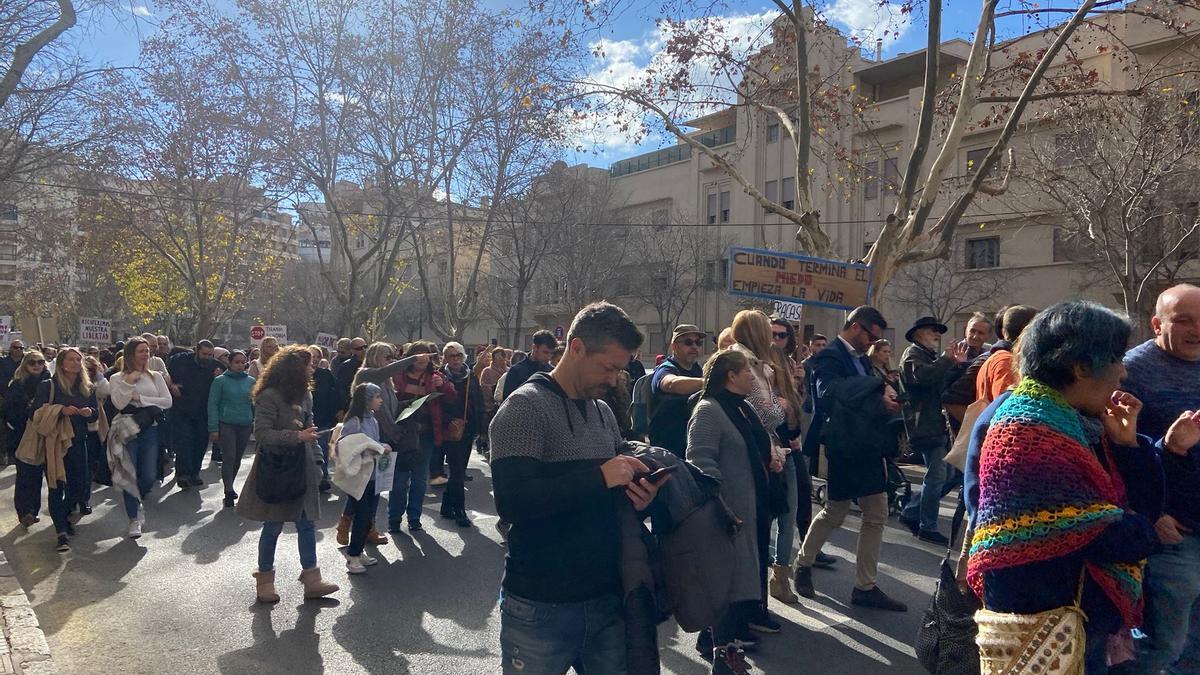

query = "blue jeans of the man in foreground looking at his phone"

[{"left": 500, "top": 591, "right": 626, "bottom": 675}]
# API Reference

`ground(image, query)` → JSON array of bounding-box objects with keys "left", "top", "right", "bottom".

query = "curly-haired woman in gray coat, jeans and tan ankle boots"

[{"left": 238, "top": 346, "right": 337, "bottom": 603}]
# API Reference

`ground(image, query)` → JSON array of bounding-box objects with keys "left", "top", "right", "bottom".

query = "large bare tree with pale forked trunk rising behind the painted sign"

[{"left": 547, "top": 0, "right": 1190, "bottom": 291}]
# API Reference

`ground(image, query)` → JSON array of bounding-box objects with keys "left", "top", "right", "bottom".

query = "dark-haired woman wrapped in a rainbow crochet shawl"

[{"left": 967, "top": 301, "right": 1163, "bottom": 675}]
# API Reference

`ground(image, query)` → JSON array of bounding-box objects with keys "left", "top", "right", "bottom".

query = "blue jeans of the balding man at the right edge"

[{"left": 1138, "top": 534, "right": 1200, "bottom": 673}]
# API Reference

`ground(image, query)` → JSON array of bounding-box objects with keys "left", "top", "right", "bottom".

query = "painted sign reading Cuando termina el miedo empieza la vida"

[{"left": 730, "top": 246, "right": 871, "bottom": 310}]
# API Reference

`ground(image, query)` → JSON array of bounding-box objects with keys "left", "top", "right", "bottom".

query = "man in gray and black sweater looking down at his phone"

[{"left": 488, "top": 303, "right": 664, "bottom": 675}]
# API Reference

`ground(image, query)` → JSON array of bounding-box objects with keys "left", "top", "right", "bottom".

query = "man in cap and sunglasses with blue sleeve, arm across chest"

[{"left": 648, "top": 323, "right": 704, "bottom": 458}]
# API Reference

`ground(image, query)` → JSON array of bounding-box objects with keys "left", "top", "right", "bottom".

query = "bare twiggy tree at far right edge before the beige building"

[{"left": 1012, "top": 81, "right": 1200, "bottom": 329}]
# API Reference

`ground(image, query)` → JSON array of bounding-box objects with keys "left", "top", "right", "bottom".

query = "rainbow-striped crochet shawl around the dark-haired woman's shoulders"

[{"left": 967, "top": 378, "right": 1142, "bottom": 628}]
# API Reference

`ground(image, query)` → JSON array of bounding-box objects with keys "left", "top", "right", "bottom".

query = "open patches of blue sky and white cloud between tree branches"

[{"left": 72, "top": 0, "right": 1060, "bottom": 167}]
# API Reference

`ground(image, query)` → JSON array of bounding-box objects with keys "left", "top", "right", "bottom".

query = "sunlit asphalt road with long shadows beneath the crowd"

[{"left": 0, "top": 446, "right": 948, "bottom": 675}]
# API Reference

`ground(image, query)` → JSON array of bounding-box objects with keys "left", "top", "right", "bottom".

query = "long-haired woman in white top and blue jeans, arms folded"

[{"left": 108, "top": 338, "right": 170, "bottom": 539}]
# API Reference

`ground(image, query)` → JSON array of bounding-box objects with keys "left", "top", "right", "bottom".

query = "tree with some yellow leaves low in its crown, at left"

[{"left": 85, "top": 22, "right": 286, "bottom": 340}]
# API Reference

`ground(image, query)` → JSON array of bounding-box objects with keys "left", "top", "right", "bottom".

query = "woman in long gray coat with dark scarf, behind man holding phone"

[{"left": 688, "top": 350, "right": 772, "bottom": 675}]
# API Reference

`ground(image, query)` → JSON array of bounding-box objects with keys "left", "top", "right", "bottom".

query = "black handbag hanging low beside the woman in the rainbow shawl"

[{"left": 916, "top": 502, "right": 980, "bottom": 675}]
